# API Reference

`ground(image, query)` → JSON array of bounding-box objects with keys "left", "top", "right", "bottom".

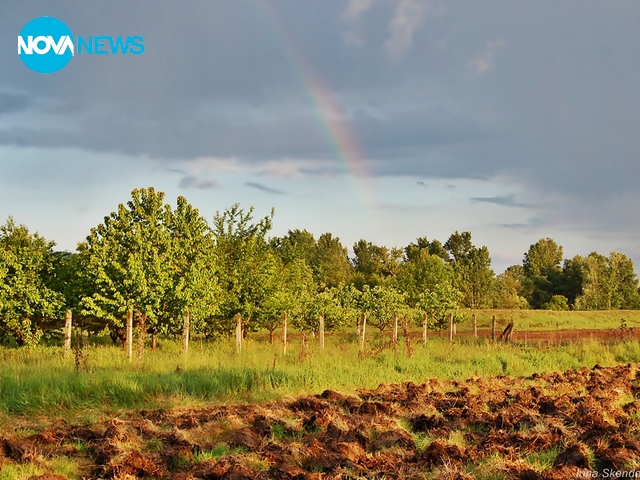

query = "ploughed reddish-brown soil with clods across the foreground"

[{"left": 0, "top": 364, "right": 640, "bottom": 480}]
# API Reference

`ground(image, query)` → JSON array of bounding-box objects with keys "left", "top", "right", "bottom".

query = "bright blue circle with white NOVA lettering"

[{"left": 18, "top": 17, "right": 74, "bottom": 73}]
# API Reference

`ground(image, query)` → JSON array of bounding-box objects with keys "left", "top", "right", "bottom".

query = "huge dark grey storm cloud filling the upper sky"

[{"left": 0, "top": 0, "right": 640, "bottom": 206}]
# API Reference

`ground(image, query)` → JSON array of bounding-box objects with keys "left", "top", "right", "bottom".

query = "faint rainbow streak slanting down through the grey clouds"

[{"left": 244, "top": 0, "right": 377, "bottom": 213}]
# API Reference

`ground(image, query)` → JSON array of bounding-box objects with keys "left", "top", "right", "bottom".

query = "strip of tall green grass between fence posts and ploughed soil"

[{"left": 0, "top": 337, "right": 640, "bottom": 416}]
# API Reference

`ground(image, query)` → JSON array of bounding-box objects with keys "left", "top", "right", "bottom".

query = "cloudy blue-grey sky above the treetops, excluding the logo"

[{"left": 0, "top": 0, "right": 640, "bottom": 273}]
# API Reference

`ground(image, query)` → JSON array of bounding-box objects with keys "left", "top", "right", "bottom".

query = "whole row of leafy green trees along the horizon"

[{"left": 0, "top": 188, "right": 640, "bottom": 344}]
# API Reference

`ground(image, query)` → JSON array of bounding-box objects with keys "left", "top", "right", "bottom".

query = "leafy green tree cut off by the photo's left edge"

[{"left": 0, "top": 217, "right": 64, "bottom": 345}]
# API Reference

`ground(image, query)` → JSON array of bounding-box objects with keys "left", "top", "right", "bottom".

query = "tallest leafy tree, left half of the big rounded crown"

[{"left": 78, "top": 187, "right": 172, "bottom": 330}]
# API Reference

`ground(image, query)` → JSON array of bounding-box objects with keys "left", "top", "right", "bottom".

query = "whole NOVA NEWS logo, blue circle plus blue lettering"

[{"left": 18, "top": 17, "right": 144, "bottom": 73}]
